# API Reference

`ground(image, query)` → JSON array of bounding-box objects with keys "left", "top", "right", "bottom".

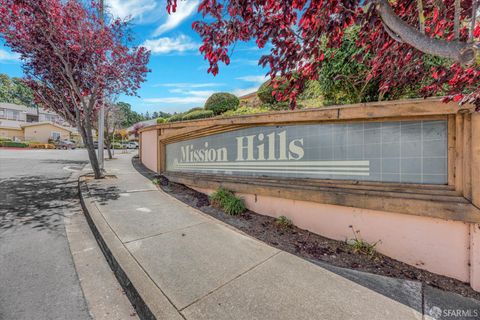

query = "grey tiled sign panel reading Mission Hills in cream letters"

[{"left": 166, "top": 120, "right": 447, "bottom": 184}]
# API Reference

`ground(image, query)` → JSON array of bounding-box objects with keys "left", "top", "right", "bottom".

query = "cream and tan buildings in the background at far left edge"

[{"left": 0, "top": 103, "right": 80, "bottom": 143}]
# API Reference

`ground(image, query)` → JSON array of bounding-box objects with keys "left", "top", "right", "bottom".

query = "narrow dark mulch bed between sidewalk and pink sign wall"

[{"left": 153, "top": 176, "right": 480, "bottom": 300}]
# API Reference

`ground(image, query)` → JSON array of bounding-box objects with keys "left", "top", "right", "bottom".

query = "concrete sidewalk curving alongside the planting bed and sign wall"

[{"left": 80, "top": 155, "right": 480, "bottom": 320}]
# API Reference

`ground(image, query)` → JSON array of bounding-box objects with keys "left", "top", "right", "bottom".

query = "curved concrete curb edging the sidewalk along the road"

[{"left": 78, "top": 176, "right": 184, "bottom": 320}]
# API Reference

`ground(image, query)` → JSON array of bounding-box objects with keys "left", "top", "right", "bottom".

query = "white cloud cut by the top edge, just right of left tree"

[{"left": 105, "top": 0, "right": 157, "bottom": 19}]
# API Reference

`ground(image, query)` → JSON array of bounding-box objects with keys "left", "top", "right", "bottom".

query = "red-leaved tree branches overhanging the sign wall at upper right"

[{"left": 167, "top": 0, "right": 480, "bottom": 108}]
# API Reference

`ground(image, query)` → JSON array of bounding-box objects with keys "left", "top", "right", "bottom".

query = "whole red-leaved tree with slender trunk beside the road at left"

[{"left": 0, "top": 0, "right": 149, "bottom": 179}]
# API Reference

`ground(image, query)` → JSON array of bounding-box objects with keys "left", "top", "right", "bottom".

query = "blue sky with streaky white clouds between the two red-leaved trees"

[{"left": 0, "top": 0, "right": 268, "bottom": 113}]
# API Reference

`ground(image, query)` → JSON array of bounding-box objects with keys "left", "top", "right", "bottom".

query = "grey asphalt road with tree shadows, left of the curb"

[{"left": 0, "top": 149, "right": 91, "bottom": 320}]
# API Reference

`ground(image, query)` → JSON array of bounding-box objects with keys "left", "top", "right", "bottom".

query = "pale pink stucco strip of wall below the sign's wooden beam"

[{"left": 193, "top": 187, "right": 480, "bottom": 290}]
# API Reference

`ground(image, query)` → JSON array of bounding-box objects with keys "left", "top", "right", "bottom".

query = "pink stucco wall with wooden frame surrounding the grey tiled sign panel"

[{"left": 140, "top": 99, "right": 480, "bottom": 291}]
